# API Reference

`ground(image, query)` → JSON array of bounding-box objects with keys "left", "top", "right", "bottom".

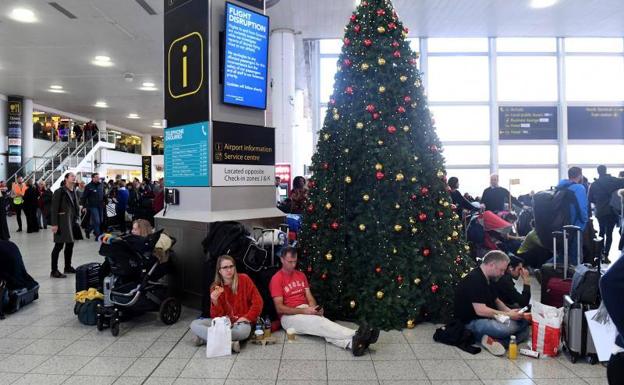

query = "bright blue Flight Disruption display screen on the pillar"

[{"left": 223, "top": 3, "right": 269, "bottom": 110}]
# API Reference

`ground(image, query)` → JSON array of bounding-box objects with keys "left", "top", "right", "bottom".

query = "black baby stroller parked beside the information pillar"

[{"left": 96, "top": 230, "right": 182, "bottom": 336}]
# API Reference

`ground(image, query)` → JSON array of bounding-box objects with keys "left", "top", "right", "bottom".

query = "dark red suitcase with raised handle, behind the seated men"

[{"left": 540, "top": 226, "right": 581, "bottom": 308}]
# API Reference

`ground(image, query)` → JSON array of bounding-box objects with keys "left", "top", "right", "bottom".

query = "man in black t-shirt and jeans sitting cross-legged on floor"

[{"left": 455, "top": 250, "right": 529, "bottom": 356}]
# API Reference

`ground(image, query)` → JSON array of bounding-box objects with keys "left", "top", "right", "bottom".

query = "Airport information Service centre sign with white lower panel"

[{"left": 212, "top": 122, "right": 275, "bottom": 186}]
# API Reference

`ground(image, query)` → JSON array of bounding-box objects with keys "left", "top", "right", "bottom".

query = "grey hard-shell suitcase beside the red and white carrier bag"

[{"left": 561, "top": 295, "right": 598, "bottom": 365}]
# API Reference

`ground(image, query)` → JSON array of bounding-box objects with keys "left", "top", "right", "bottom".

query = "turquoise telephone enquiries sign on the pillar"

[{"left": 165, "top": 122, "right": 210, "bottom": 187}]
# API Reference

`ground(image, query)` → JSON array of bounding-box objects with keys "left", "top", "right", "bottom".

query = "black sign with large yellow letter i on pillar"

[{"left": 164, "top": 0, "right": 210, "bottom": 127}]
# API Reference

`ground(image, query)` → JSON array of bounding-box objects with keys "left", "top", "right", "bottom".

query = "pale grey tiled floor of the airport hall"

[{"left": 0, "top": 218, "right": 607, "bottom": 385}]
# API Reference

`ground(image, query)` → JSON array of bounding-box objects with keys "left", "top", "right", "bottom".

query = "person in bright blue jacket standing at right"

[{"left": 557, "top": 167, "right": 589, "bottom": 265}]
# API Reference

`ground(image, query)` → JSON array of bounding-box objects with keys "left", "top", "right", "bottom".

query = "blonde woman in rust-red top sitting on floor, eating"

[{"left": 191, "top": 255, "right": 263, "bottom": 353}]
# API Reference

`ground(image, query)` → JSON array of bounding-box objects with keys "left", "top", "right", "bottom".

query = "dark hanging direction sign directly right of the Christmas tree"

[{"left": 498, "top": 106, "right": 557, "bottom": 140}]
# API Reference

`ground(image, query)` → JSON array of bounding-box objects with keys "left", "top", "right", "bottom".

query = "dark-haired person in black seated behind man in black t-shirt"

[{"left": 494, "top": 256, "right": 531, "bottom": 309}]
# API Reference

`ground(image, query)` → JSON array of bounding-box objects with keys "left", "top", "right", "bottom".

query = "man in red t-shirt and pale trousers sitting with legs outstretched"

[{"left": 270, "top": 247, "right": 379, "bottom": 356}]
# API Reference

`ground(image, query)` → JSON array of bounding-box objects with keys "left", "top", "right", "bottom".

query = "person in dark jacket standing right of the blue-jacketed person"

[{"left": 588, "top": 165, "right": 624, "bottom": 263}]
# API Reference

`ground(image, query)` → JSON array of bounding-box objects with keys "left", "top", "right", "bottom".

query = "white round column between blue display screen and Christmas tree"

[{"left": 269, "top": 29, "right": 296, "bottom": 175}]
